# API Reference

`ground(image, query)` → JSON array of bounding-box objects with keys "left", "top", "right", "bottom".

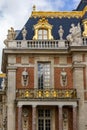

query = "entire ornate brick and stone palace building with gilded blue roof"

[{"left": 2, "top": 0, "right": 87, "bottom": 130}]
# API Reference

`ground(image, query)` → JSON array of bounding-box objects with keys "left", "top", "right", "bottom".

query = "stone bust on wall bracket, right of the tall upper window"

[{"left": 60, "top": 68, "right": 67, "bottom": 86}]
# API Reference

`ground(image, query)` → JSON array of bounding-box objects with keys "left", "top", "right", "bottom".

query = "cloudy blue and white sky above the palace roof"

[{"left": 0, "top": 0, "right": 80, "bottom": 71}]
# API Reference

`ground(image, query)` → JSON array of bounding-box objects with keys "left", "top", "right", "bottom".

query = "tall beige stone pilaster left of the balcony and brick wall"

[{"left": 7, "top": 67, "right": 16, "bottom": 130}]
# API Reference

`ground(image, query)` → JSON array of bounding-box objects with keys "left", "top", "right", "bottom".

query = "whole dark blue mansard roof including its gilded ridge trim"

[{"left": 16, "top": 0, "right": 87, "bottom": 40}]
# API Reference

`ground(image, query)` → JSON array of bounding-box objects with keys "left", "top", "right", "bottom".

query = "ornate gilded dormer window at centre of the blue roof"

[{"left": 33, "top": 18, "right": 53, "bottom": 40}]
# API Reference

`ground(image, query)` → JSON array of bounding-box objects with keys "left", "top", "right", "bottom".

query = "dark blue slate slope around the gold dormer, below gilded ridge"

[{"left": 16, "top": 18, "right": 81, "bottom": 40}]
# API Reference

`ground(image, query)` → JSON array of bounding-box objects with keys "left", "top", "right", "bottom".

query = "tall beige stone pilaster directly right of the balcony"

[{"left": 73, "top": 63, "right": 85, "bottom": 130}]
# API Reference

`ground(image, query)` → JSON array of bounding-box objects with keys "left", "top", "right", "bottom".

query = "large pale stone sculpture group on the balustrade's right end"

[{"left": 66, "top": 23, "right": 82, "bottom": 46}]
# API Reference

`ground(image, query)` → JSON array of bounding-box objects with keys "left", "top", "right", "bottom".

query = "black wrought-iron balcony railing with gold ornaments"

[{"left": 16, "top": 89, "right": 77, "bottom": 99}]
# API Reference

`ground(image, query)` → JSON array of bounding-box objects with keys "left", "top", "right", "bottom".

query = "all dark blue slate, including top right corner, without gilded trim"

[{"left": 16, "top": 0, "right": 87, "bottom": 40}]
